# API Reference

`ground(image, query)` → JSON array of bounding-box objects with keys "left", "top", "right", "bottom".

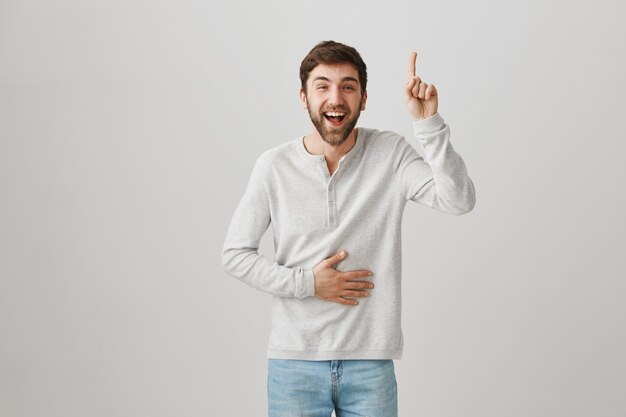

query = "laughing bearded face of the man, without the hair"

[{"left": 300, "top": 63, "right": 367, "bottom": 146}]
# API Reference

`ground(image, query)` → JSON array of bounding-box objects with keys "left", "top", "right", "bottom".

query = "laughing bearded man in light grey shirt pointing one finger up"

[{"left": 222, "top": 41, "right": 475, "bottom": 417}]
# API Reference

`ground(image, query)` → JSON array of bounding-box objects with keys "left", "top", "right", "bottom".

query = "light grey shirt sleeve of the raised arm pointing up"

[{"left": 395, "top": 113, "right": 476, "bottom": 215}]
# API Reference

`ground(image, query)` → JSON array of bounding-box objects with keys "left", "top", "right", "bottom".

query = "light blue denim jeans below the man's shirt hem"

[{"left": 267, "top": 359, "right": 398, "bottom": 417}]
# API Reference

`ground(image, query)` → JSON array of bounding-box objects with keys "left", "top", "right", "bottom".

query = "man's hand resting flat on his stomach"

[{"left": 313, "top": 251, "right": 374, "bottom": 305}]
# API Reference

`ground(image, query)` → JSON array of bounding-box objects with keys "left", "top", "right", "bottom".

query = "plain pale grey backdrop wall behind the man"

[{"left": 0, "top": 0, "right": 626, "bottom": 417}]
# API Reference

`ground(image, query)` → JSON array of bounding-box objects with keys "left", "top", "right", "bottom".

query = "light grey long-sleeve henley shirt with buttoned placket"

[{"left": 222, "top": 113, "right": 475, "bottom": 360}]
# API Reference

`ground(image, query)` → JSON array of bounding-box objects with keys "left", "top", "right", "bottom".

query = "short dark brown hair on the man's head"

[{"left": 300, "top": 41, "right": 367, "bottom": 94}]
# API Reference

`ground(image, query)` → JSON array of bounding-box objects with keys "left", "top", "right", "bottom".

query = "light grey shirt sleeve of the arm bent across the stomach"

[{"left": 222, "top": 159, "right": 315, "bottom": 298}]
